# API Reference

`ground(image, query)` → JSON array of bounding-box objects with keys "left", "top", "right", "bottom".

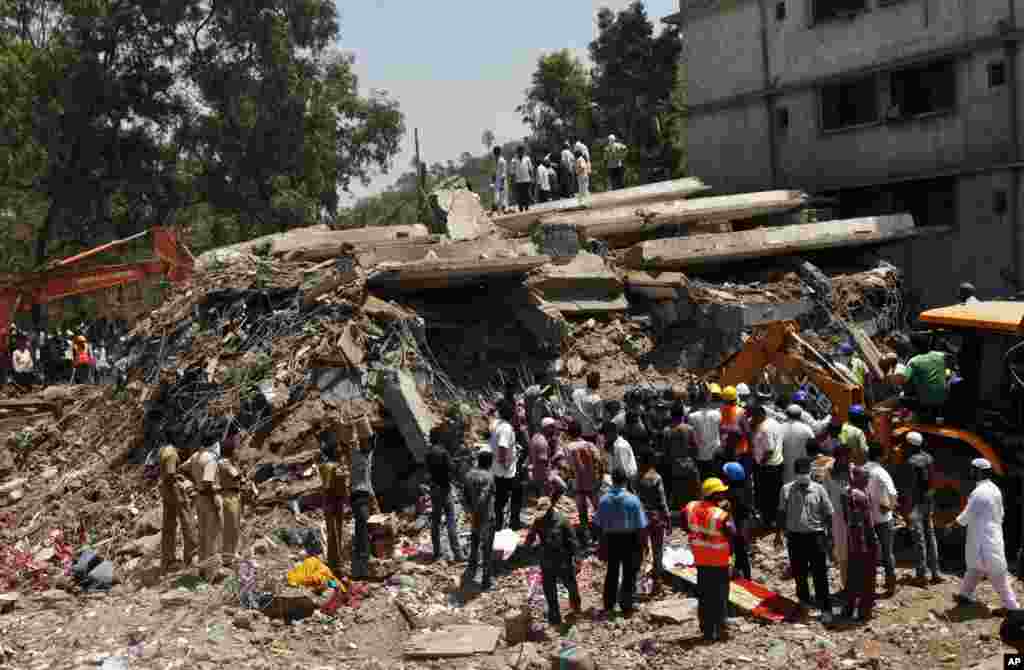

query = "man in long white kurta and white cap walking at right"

[{"left": 954, "top": 458, "right": 1019, "bottom": 610}]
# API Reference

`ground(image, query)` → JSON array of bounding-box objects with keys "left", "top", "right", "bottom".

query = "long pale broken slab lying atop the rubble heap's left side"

[{"left": 196, "top": 223, "right": 430, "bottom": 268}]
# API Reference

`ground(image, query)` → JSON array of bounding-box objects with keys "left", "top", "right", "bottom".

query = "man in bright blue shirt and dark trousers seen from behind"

[{"left": 595, "top": 467, "right": 647, "bottom": 617}]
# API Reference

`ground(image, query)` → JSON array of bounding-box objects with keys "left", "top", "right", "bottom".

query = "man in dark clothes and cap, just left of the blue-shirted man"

[{"left": 526, "top": 488, "right": 583, "bottom": 626}]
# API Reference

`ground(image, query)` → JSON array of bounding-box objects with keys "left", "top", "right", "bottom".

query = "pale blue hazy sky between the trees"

[{"left": 337, "top": 0, "right": 679, "bottom": 204}]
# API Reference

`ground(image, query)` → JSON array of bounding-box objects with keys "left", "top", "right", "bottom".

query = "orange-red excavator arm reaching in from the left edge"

[{"left": 0, "top": 226, "right": 195, "bottom": 344}]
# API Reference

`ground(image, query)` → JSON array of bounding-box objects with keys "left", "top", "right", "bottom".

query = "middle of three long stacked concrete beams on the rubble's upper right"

[{"left": 541, "top": 191, "right": 807, "bottom": 246}]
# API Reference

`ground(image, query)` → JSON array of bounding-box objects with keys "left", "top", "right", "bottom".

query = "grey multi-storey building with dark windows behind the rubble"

[{"left": 665, "top": 0, "right": 1024, "bottom": 306}]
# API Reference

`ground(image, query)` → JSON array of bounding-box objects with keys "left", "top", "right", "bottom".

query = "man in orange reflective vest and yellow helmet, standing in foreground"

[{"left": 682, "top": 477, "right": 736, "bottom": 641}]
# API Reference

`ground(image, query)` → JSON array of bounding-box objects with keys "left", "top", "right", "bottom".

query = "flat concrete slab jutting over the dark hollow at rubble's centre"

[{"left": 367, "top": 256, "right": 551, "bottom": 291}]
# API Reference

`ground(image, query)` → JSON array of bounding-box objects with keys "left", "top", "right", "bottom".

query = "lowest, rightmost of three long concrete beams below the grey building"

[{"left": 625, "top": 214, "right": 918, "bottom": 269}]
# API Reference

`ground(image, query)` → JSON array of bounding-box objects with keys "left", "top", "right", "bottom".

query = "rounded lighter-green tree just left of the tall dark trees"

[{"left": 516, "top": 49, "right": 591, "bottom": 146}]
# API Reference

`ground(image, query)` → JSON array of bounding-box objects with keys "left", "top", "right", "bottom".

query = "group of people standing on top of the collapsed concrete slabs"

[{"left": 492, "top": 134, "right": 628, "bottom": 213}]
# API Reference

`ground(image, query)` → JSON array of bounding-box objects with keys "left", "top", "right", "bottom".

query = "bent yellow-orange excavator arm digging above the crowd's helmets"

[{"left": 719, "top": 321, "right": 864, "bottom": 421}]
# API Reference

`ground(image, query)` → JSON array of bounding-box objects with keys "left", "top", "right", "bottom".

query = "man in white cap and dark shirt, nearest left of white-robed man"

[{"left": 905, "top": 431, "right": 942, "bottom": 586}]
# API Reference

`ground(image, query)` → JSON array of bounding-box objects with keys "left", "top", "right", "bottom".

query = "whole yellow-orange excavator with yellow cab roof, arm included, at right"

[{"left": 719, "top": 309, "right": 1024, "bottom": 561}]
